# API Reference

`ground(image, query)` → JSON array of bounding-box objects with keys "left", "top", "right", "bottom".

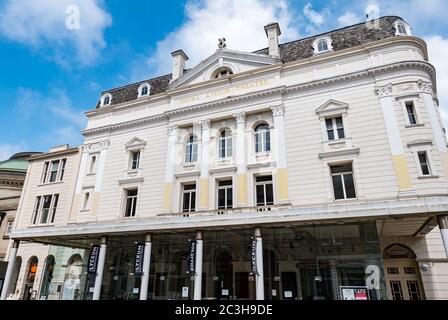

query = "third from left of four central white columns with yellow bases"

[{"left": 233, "top": 112, "right": 247, "bottom": 207}]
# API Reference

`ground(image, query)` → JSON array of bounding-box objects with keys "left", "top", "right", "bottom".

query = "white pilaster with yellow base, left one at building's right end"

[{"left": 376, "top": 84, "right": 414, "bottom": 195}]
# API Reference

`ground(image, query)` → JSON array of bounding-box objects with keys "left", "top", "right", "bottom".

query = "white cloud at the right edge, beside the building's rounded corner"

[{"left": 425, "top": 35, "right": 448, "bottom": 129}]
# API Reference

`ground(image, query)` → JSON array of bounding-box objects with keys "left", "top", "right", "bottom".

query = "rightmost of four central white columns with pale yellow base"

[{"left": 271, "top": 105, "right": 290, "bottom": 204}]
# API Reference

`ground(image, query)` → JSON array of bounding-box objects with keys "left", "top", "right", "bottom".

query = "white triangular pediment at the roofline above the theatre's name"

[{"left": 170, "top": 49, "right": 281, "bottom": 89}]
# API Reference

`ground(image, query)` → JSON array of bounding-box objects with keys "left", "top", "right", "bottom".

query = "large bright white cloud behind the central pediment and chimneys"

[{"left": 145, "top": 0, "right": 298, "bottom": 75}]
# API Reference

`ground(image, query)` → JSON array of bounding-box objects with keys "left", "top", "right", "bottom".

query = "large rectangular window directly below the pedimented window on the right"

[{"left": 330, "top": 163, "right": 356, "bottom": 200}]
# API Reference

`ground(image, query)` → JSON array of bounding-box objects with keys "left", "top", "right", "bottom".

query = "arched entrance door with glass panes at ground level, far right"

[{"left": 384, "top": 245, "right": 425, "bottom": 300}]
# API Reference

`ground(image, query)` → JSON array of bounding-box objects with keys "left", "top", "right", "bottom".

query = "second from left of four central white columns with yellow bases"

[{"left": 199, "top": 120, "right": 211, "bottom": 210}]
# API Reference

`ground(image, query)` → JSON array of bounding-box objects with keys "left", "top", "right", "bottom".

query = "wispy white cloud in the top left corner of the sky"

[{"left": 0, "top": 0, "right": 112, "bottom": 67}]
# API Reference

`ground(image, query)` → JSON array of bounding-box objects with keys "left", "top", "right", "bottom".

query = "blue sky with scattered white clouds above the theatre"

[{"left": 0, "top": 0, "right": 448, "bottom": 160}]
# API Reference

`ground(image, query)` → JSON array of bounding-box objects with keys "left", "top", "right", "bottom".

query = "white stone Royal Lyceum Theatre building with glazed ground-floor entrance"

[{"left": 2, "top": 17, "right": 448, "bottom": 300}]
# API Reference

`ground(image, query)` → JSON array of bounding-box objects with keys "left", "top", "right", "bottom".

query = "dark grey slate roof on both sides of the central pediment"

[{"left": 96, "top": 16, "right": 403, "bottom": 108}]
